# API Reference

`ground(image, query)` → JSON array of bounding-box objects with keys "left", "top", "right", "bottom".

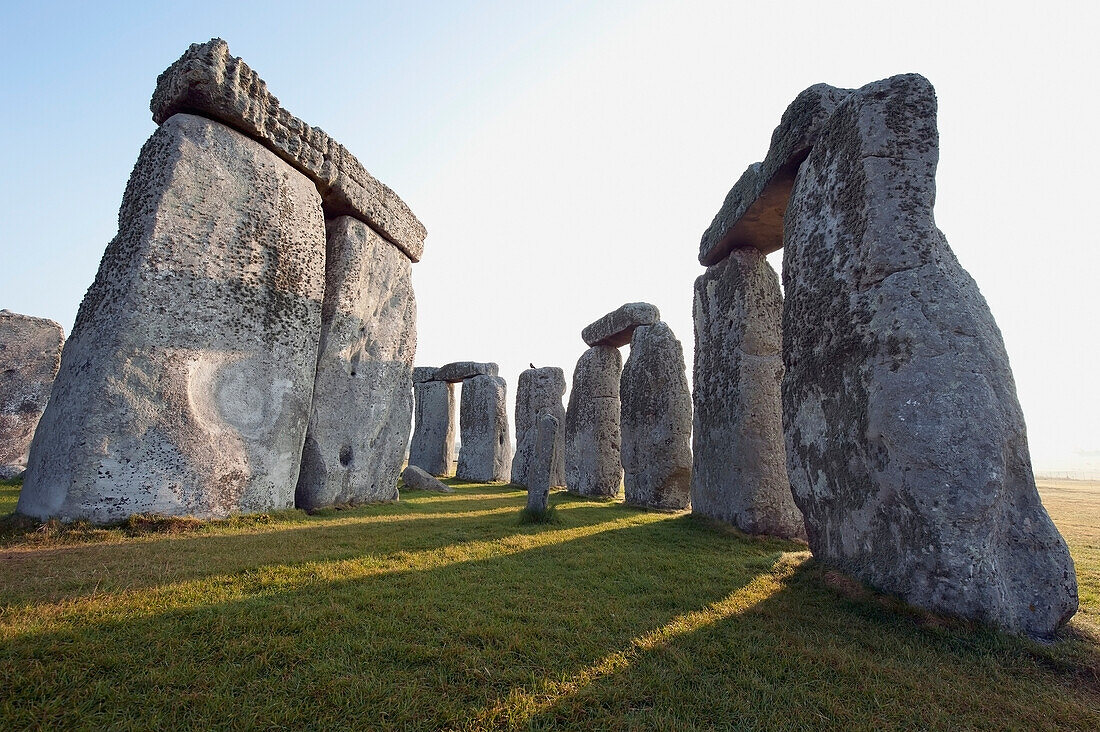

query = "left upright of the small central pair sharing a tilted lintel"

[{"left": 565, "top": 346, "right": 623, "bottom": 498}]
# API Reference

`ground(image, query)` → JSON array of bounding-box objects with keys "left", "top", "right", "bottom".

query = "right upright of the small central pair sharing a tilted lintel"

[{"left": 619, "top": 323, "right": 691, "bottom": 510}]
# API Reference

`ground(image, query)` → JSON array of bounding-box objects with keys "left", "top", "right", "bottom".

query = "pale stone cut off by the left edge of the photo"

[{"left": 0, "top": 310, "right": 65, "bottom": 480}]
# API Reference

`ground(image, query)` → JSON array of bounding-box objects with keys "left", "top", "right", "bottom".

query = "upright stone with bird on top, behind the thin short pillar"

[{"left": 512, "top": 367, "right": 565, "bottom": 487}]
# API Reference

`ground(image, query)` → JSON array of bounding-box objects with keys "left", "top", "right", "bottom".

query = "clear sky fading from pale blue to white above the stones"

[{"left": 0, "top": 0, "right": 1100, "bottom": 477}]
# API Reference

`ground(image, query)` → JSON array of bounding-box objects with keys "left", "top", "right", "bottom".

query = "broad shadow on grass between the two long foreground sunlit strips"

[{"left": 0, "top": 506, "right": 791, "bottom": 729}]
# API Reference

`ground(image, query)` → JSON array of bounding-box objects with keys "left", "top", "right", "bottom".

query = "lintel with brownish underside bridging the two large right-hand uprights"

[{"left": 699, "top": 84, "right": 851, "bottom": 266}]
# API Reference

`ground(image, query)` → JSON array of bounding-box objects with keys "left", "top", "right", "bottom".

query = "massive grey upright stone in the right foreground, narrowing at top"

[{"left": 783, "top": 75, "right": 1077, "bottom": 636}]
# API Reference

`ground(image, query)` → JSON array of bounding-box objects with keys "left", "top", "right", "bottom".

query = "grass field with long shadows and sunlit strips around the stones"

[{"left": 0, "top": 480, "right": 1100, "bottom": 730}]
